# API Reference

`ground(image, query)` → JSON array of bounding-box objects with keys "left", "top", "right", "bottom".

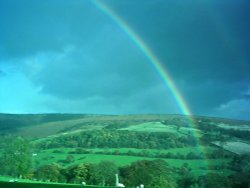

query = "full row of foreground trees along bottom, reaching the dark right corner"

[{"left": 29, "top": 159, "right": 250, "bottom": 188}]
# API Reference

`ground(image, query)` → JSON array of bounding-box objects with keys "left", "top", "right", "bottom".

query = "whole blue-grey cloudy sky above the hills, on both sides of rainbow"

[{"left": 0, "top": 0, "right": 250, "bottom": 120}]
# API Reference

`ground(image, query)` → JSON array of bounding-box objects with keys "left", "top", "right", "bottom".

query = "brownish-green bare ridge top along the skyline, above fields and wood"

[{"left": 0, "top": 113, "right": 250, "bottom": 137}]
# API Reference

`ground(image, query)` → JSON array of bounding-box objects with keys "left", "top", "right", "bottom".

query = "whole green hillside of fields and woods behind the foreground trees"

[{"left": 0, "top": 114, "right": 250, "bottom": 188}]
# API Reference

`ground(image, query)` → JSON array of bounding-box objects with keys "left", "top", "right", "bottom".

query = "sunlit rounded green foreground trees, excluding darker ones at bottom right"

[{"left": 31, "top": 160, "right": 176, "bottom": 188}]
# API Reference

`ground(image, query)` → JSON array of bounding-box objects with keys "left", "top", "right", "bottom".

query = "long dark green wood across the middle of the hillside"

[{"left": 38, "top": 130, "right": 195, "bottom": 149}]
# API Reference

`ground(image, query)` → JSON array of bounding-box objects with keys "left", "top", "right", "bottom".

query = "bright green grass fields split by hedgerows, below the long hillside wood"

[{"left": 35, "top": 147, "right": 230, "bottom": 175}]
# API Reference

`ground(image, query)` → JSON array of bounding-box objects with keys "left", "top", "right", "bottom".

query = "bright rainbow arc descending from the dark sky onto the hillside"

[{"left": 93, "top": 0, "right": 205, "bottom": 164}]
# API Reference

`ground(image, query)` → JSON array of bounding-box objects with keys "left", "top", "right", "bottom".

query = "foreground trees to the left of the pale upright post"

[{"left": 34, "top": 161, "right": 118, "bottom": 186}]
